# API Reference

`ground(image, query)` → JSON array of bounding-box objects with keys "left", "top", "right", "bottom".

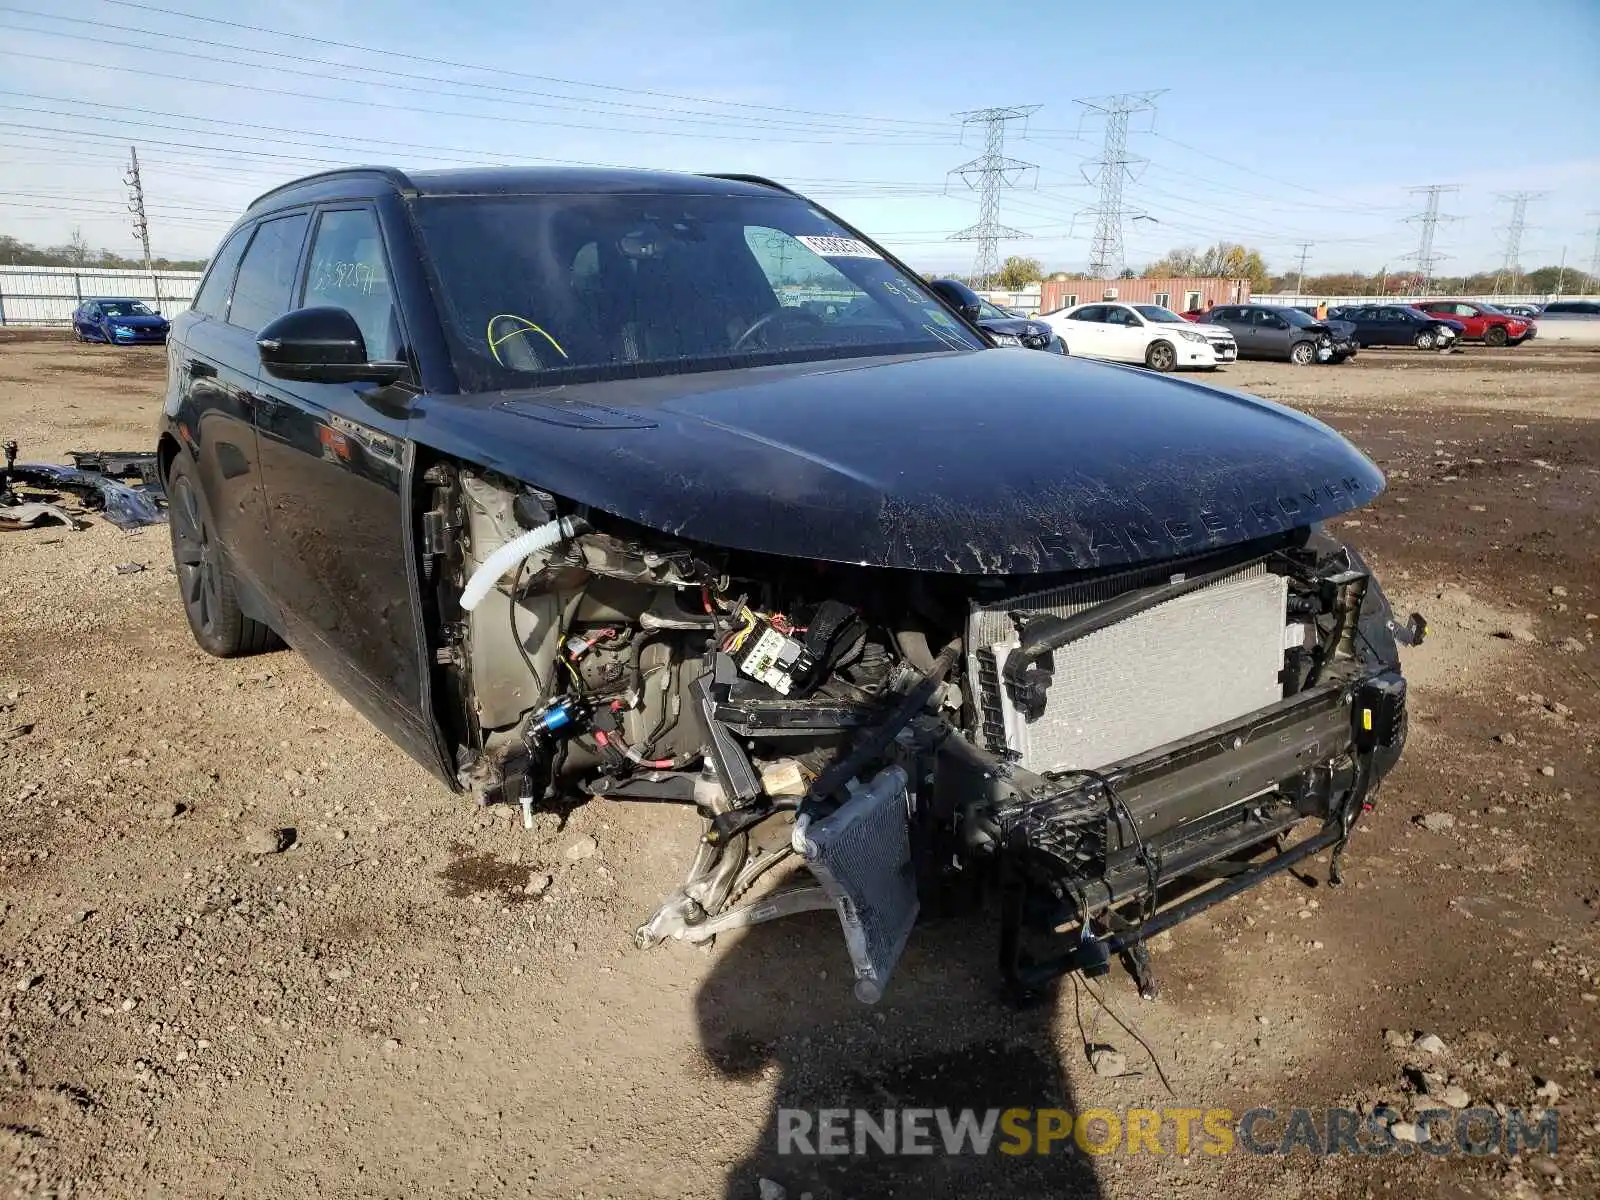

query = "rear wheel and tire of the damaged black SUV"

[{"left": 166, "top": 451, "right": 277, "bottom": 658}]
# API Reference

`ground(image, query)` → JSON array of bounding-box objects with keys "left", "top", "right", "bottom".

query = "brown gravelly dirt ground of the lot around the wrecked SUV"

[{"left": 0, "top": 333, "right": 1600, "bottom": 1200}]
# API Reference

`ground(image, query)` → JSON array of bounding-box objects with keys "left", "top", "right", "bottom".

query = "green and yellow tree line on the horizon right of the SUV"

[{"left": 965, "top": 242, "right": 1600, "bottom": 296}]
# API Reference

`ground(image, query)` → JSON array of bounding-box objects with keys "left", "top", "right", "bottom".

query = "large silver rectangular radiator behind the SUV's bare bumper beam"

[{"left": 966, "top": 563, "right": 1288, "bottom": 771}]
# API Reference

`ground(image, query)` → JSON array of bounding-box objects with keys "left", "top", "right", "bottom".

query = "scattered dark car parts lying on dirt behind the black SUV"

[{"left": 0, "top": 440, "right": 166, "bottom": 530}]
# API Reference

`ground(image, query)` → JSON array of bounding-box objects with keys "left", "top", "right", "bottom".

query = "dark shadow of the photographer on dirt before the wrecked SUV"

[{"left": 696, "top": 912, "right": 1101, "bottom": 1200}]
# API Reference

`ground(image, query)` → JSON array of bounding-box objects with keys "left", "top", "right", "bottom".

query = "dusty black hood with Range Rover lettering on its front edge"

[{"left": 410, "top": 350, "right": 1384, "bottom": 574}]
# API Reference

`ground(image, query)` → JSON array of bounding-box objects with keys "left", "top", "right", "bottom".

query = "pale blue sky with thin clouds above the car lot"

[{"left": 0, "top": 0, "right": 1600, "bottom": 274}]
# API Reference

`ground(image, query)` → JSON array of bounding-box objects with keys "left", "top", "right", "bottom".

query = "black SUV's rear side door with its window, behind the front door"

[{"left": 168, "top": 214, "right": 291, "bottom": 614}]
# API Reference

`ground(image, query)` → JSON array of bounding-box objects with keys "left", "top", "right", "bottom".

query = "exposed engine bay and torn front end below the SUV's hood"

[{"left": 422, "top": 464, "right": 1424, "bottom": 1002}]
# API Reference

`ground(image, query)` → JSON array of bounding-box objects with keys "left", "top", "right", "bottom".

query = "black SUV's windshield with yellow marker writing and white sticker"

[{"left": 413, "top": 194, "right": 984, "bottom": 390}]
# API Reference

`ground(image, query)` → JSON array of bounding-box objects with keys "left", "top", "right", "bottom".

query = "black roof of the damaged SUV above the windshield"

[{"left": 250, "top": 166, "right": 787, "bottom": 208}]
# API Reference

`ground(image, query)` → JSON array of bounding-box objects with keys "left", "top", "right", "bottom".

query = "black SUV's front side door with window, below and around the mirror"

[{"left": 246, "top": 203, "right": 437, "bottom": 765}]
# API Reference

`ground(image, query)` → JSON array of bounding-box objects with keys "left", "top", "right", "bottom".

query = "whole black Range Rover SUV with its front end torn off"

[{"left": 160, "top": 170, "right": 1419, "bottom": 1000}]
